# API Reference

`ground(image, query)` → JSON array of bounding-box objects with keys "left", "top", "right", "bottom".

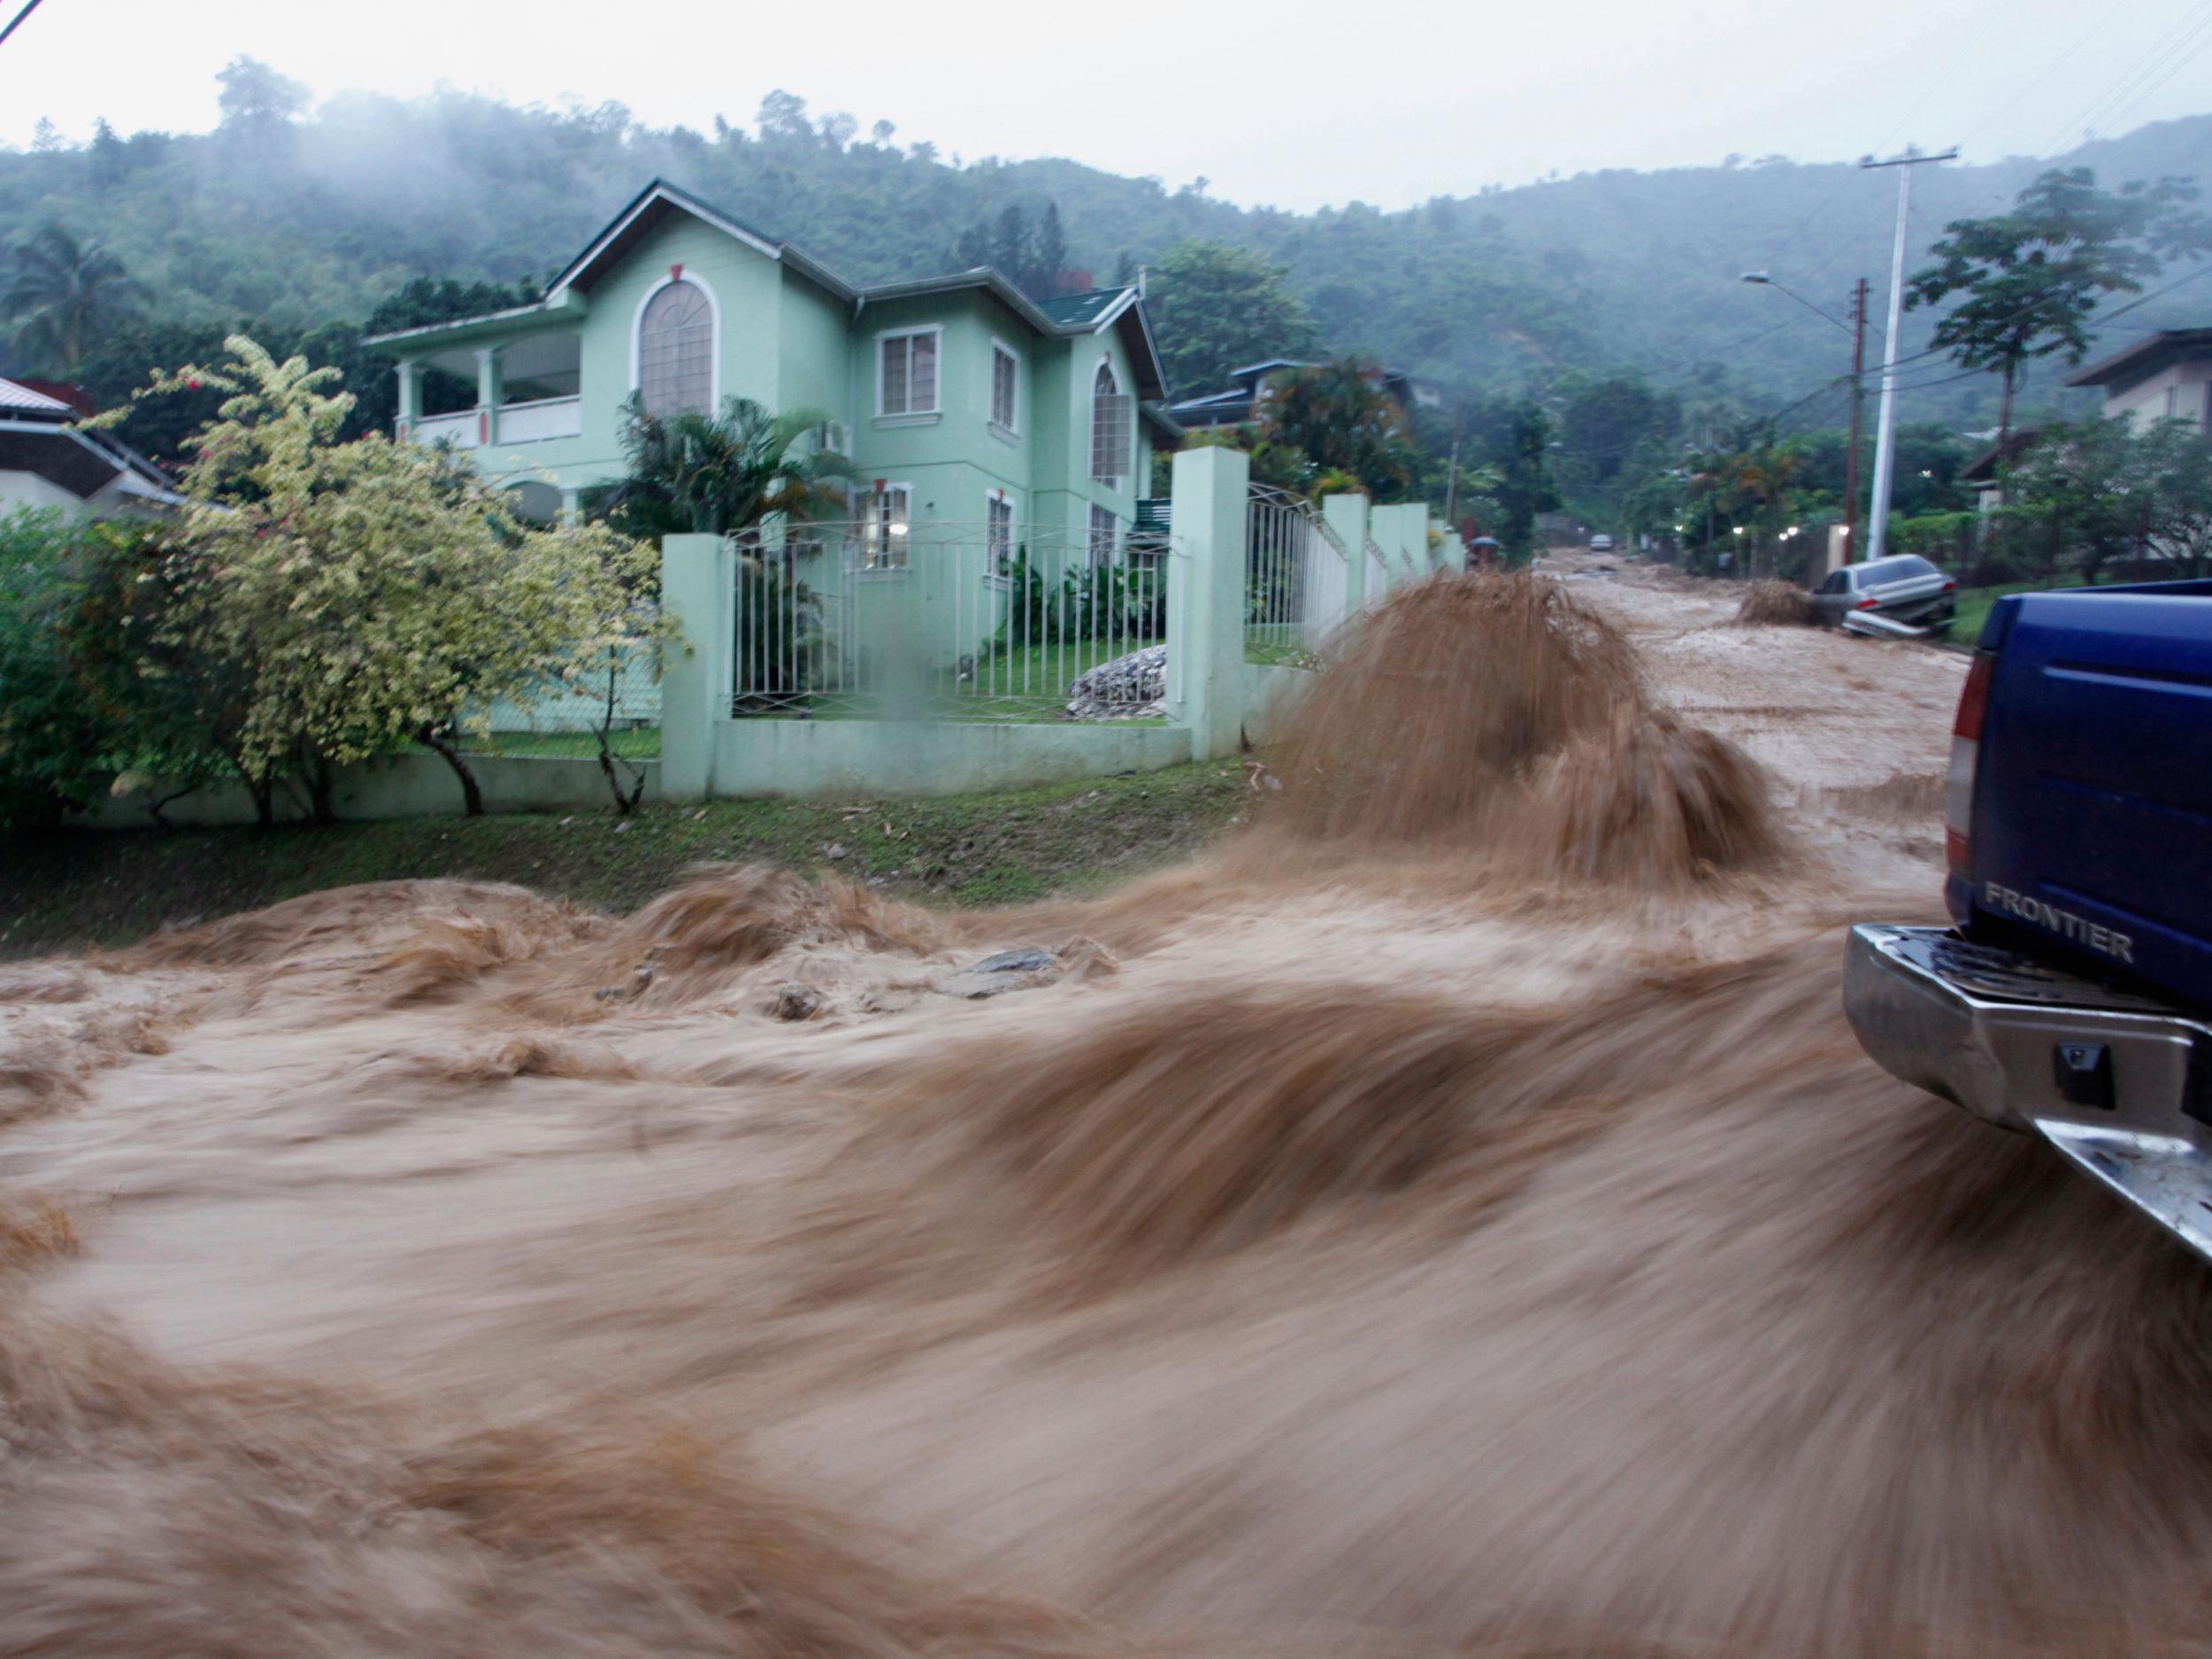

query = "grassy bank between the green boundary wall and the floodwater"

[{"left": 0, "top": 761, "right": 1250, "bottom": 958}]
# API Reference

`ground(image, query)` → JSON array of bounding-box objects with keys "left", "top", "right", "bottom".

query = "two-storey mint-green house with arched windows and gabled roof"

[{"left": 370, "top": 181, "right": 1179, "bottom": 553}]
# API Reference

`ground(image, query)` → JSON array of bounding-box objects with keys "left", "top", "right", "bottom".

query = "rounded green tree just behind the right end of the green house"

[{"left": 1146, "top": 242, "right": 1321, "bottom": 394}]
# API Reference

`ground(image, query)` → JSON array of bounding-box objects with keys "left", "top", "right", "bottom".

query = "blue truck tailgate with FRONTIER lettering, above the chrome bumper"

[{"left": 1971, "top": 582, "right": 2212, "bottom": 1007}]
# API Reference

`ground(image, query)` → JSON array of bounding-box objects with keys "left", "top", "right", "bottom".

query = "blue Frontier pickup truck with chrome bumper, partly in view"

[{"left": 1843, "top": 582, "right": 2212, "bottom": 1256}]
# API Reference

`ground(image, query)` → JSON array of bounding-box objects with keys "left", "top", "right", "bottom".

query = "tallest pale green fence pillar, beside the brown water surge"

[{"left": 1168, "top": 447, "right": 1252, "bottom": 761}]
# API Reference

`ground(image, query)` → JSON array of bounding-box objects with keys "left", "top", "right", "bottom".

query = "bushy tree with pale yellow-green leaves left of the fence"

[{"left": 97, "top": 334, "right": 659, "bottom": 821}]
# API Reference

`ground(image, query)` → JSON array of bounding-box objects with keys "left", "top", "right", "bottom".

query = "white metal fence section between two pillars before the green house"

[{"left": 730, "top": 513, "right": 1172, "bottom": 721}]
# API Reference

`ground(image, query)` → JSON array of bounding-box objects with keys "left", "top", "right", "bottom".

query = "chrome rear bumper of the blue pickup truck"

[{"left": 1843, "top": 923, "right": 2212, "bottom": 1256}]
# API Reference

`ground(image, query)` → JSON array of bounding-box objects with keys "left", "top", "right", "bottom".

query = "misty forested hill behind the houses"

[{"left": 0, "top": 78, "right": 2212, "bottom": 419}]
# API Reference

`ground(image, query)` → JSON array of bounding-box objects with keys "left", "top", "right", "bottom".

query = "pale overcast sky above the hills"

[{"left": 0, "top": 0, "right": 2212, "bottom": 208}]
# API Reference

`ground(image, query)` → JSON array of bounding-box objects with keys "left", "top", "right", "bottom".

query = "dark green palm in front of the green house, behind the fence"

[{"left": 609, "top": 396, "right": 854, "bottom": 535}]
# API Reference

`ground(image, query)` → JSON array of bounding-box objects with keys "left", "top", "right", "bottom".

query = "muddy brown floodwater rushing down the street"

[{"left": 0, "top": 560, "right": 2212, "bottom": 1659}]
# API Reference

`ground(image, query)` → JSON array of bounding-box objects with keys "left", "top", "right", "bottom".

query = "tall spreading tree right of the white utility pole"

[{"left": 1905, "top": 168, "right": 2212, "bottom": 449}]
